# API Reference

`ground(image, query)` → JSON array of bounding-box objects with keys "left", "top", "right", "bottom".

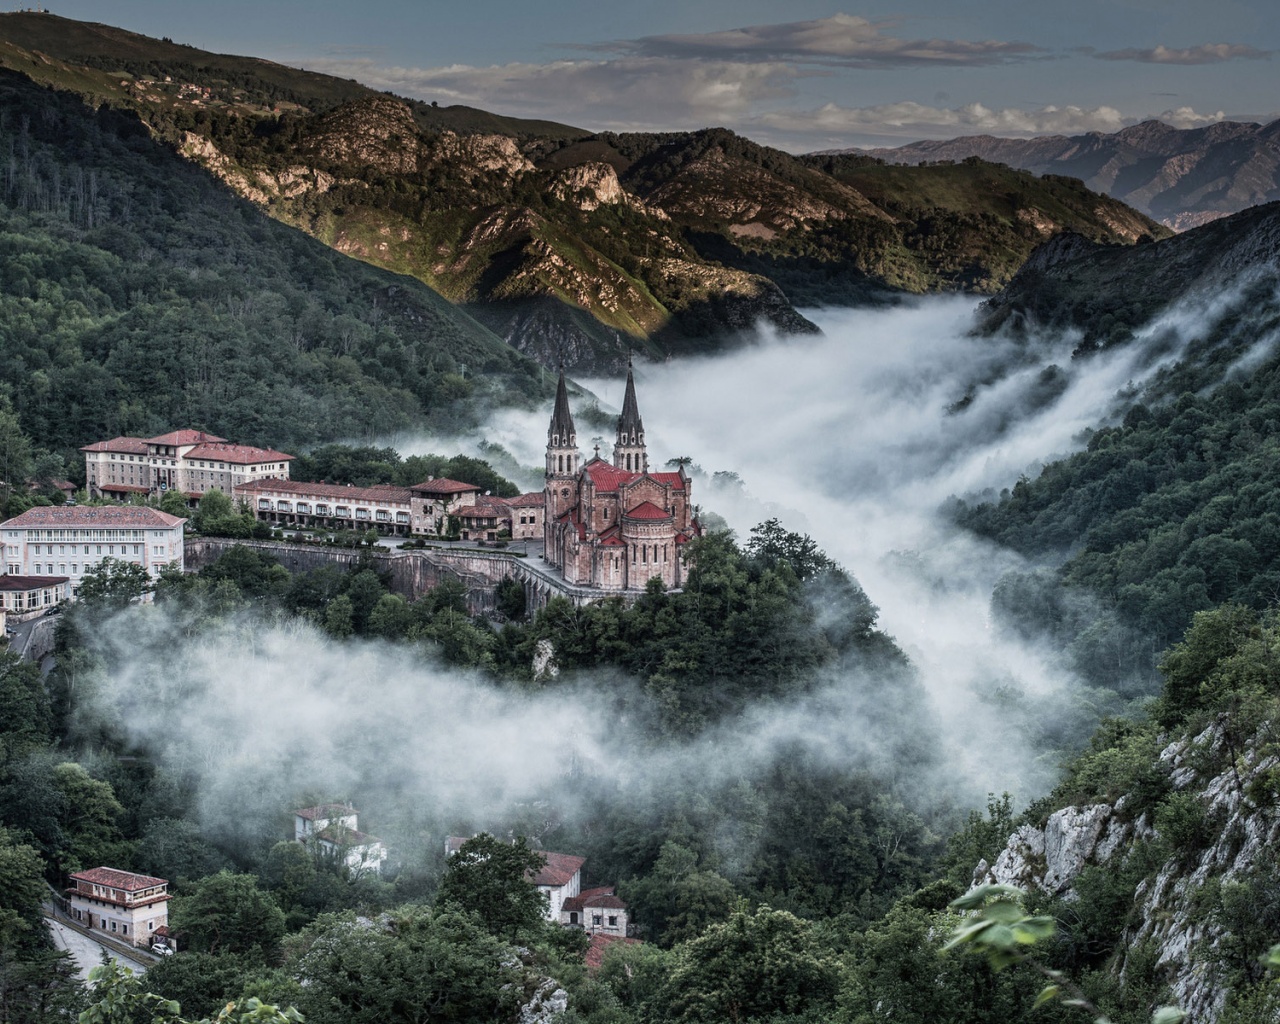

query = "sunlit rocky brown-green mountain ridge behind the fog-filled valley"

[{"left": 0, "top": 12, "right": 1167, "bottom": 370}]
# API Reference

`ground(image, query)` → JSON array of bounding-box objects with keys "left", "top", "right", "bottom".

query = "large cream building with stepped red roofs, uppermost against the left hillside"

[{"left": 81, "top": 430, "right": 293, "bottom": 500}]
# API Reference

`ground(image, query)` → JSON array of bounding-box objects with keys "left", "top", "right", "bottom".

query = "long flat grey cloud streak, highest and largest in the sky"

[{"left": 599, "top": 14, "right": 1043, "bottom": 68}]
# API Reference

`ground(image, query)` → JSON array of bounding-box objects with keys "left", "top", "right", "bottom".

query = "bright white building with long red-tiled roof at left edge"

[{"left": 0, "top": 506, "right": 186, "bottom": 598}]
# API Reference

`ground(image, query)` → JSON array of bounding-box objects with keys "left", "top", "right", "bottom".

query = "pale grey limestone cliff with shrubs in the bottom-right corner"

[{"left": 978, "top": 716, "right": 1280, "bottom": 1024}]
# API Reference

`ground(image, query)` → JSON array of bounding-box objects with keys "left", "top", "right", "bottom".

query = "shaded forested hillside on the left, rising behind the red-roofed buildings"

[{"left": 0, "top": 73, "right": 545, "bottom": 471}]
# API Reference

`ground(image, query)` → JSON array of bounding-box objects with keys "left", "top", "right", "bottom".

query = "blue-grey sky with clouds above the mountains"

[{"left": 40, "top": 0, "right": 1280, "bottom": 151}]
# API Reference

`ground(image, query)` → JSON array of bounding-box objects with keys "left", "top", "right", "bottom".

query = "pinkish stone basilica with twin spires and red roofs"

[{"left": 543, "top": 366, "right": 701, "bottom": 591}]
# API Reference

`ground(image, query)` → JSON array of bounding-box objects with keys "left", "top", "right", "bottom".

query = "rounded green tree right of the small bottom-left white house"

[{"left": 170, "top": 870, "right": 284, "bottom": 952}]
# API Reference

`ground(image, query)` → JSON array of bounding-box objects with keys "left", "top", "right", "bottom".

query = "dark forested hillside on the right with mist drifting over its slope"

[{"left": 952, "top": 204, "right": 1280, "bottom": 680}]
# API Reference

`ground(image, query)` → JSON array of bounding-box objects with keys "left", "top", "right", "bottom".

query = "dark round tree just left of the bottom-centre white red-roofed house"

[{"left": 435, "top": 832, "right": 547, "bottom": 938}]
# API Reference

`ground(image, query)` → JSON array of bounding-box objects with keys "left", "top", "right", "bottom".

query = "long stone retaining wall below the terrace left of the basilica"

[{"left": 186, "top": 538, "right": 607, "bottom": 614}]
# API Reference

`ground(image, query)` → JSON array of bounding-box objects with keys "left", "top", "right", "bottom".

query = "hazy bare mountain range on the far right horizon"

[{"left": 840, "top": 120, "right": 1280, "bottom": 230}]
